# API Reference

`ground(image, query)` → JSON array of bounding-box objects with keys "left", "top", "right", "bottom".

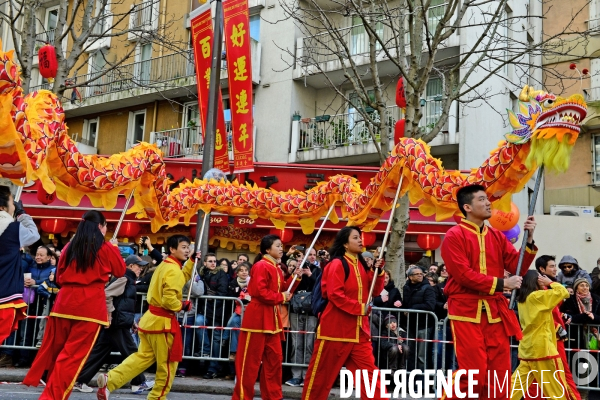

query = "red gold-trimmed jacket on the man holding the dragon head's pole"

[{"left": 442, "top": 219, "right": 537, "bottom": 323}]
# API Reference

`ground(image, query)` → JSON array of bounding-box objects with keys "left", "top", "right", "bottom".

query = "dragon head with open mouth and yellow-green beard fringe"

[{"left": 505, "top": 86, "right": 587, "bottom": 172}]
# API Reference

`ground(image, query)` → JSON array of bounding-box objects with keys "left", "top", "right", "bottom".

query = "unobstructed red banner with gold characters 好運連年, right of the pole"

[{"left": 223, "top": 0, "right": 254, "bottom": 173}]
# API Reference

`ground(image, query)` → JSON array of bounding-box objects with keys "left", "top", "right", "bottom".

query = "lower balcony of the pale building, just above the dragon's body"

[{"left": 288, "top": 100, "right": 458, "bottom": 164}]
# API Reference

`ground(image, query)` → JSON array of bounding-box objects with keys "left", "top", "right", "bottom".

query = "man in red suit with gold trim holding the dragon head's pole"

[{"left": 442, "top": 185, "right": 537, "bottom": 400}]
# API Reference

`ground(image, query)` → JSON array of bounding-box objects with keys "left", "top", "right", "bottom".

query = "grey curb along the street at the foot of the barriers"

[{"left": 0, "top": 368, "right": 340, "bottom": 400}]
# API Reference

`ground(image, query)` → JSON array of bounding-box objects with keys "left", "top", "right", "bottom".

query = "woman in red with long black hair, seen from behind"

[{"left": 23, "top": 210, "right": 126, "bottom": 400}]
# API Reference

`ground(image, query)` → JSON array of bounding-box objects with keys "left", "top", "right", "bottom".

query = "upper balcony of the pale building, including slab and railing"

[{"left": 293, "top": 4, "right": 460, "bottom": 89}]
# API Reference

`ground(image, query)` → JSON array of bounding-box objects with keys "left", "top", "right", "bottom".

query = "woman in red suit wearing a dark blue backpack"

[{"left": 302, "top": 226, "right": 385, "bottom": 400}]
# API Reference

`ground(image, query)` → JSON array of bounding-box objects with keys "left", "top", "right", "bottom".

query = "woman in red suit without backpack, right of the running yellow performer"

[{"left": 233, "top": 235, "right": 302, "bottom": 400}]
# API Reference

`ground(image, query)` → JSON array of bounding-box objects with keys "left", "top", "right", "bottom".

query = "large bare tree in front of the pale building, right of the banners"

[{"left": 280, "top": 0, "right": 589, "bottom": 285}]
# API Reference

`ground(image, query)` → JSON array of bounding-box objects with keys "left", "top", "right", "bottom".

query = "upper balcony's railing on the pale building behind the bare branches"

[{"left": 299, "top": 4, "right": 447, "bottom": 67}]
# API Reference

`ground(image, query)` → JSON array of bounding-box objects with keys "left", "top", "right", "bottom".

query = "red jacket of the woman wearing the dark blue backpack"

[{"left": 317, "top": 253, "right": 385, "bottom": 343}]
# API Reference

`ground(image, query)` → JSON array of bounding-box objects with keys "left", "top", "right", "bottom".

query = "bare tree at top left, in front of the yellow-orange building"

[{"left": 0, "top": 0, "right": 188, "bottom": 95}]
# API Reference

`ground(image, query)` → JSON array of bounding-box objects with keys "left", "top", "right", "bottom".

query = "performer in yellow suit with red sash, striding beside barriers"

[{"left": 97, "top": 235, "right": 194, "bottom": 400}]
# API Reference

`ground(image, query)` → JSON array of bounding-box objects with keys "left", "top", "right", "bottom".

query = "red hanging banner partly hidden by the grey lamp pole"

[{"left": 191, "top": 3, "right": 230, "bottom": 174}]
